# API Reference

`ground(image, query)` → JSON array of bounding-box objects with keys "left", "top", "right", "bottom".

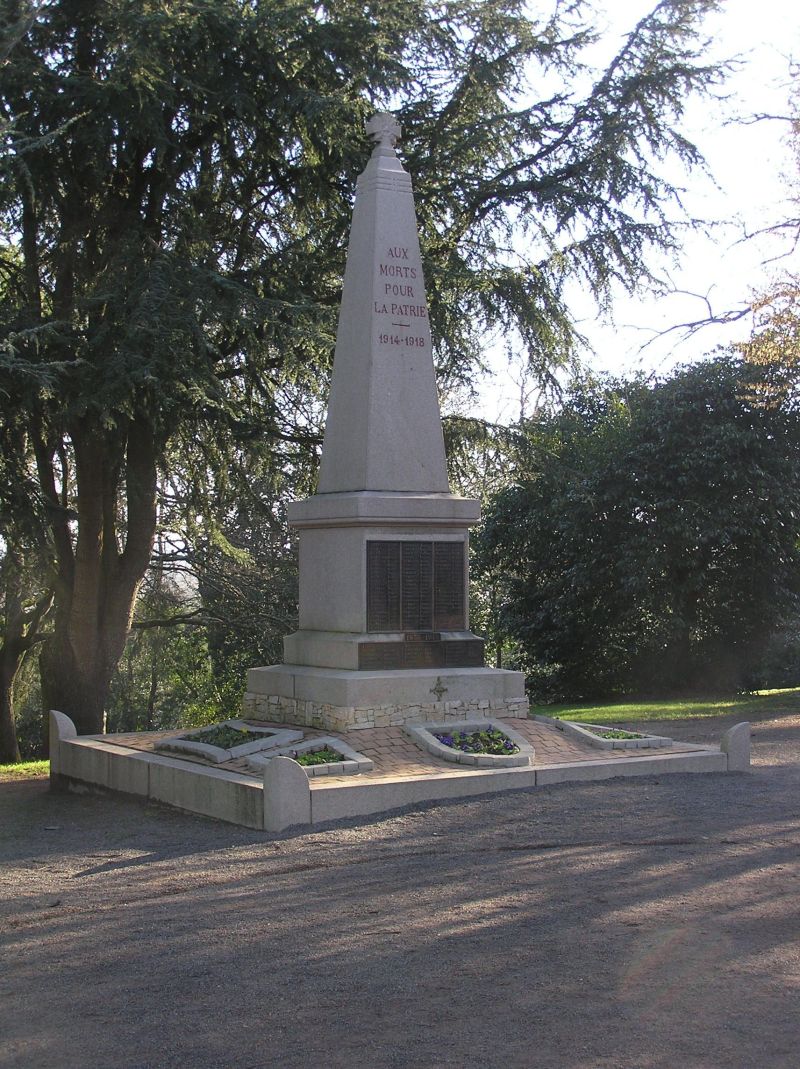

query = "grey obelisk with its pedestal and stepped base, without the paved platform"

[{"left": 244, "top": 113, "right": 527, "bottom": 730}]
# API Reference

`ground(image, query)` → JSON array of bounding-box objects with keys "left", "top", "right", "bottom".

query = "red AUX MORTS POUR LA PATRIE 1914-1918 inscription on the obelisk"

[{"left": 373, "top": 245, "right": 428, "bottom": 348}]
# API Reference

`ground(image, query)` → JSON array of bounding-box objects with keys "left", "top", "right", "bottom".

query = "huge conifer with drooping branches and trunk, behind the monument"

[{"left": 0, "top": 0, "right": 719, "bottom": 731}]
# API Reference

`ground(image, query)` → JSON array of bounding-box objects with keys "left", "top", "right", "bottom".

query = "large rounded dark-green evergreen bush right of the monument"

[{"left": 480, "top": 357, "right": 800, "bottom": 697}]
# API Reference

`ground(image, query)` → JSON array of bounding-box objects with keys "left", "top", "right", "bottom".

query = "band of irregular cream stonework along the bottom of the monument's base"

[{"left": 242, "top": 692, "right": 528, "bottom": 731}]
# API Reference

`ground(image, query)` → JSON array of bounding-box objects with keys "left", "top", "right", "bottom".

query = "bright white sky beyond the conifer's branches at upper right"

[{"left": 480, "top": 0, "right": 800, "bottom": 421}]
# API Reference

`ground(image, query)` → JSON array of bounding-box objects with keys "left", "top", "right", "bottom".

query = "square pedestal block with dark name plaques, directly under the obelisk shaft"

[{"left": 283, "top": 491, "right": 483, "bottom": 670}]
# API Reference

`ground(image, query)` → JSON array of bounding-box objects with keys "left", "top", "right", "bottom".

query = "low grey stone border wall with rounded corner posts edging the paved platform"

[{"left": 45, "top": 699, "right": 750, "bottom": 832}]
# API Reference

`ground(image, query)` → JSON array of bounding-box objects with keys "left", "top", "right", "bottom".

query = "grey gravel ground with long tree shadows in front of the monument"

[{"left": 0, "top": 716, "right": 800, "bottom": 1069}]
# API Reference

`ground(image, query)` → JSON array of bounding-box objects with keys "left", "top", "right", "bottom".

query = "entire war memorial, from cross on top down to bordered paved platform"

[{"left": 50, "top": 114, "right": 750, "bottom": 832}]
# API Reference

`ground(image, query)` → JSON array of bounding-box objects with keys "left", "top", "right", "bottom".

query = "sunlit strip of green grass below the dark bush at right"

[{"left": 532, "top": 687, "right": 800, "bottom": 724}]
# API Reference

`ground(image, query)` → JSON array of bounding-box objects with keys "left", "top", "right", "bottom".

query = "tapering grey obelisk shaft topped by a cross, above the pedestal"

[{"left": 319, "top": 114, "right": 450, "bottom": 494}]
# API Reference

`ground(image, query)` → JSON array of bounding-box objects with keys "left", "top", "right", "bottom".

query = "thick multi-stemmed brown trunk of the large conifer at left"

[{"left": 40, "top": 420, "right": 156, "bottom": 734}]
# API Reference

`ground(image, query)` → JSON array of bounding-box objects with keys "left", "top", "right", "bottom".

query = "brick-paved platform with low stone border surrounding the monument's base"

[{"left": 50, "top": 713, "right": 727, "bottom": 832}]
